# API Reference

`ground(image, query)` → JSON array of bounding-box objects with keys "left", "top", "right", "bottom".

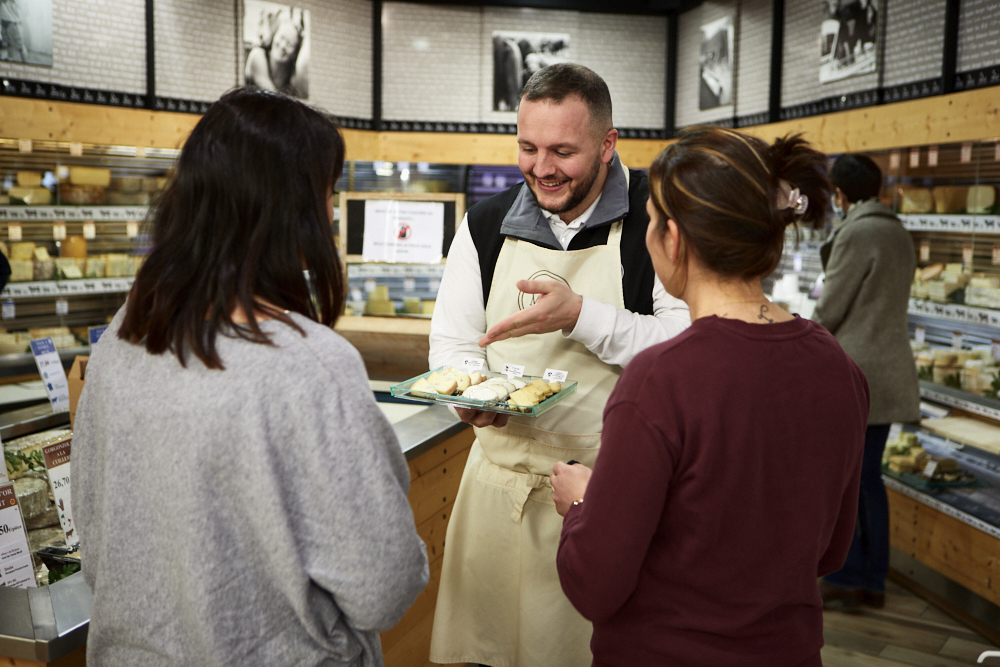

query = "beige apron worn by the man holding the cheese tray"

[{"left": 430, "top": 221, "right": 625, "bottom": 667}]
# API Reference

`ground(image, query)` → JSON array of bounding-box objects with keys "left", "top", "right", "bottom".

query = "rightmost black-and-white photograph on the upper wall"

[{"left": 819, "top": 0, "right": 878, "bottom": 83}]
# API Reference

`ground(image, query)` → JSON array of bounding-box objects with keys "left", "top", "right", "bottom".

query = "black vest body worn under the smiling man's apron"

[{"left": 468, "top": 169, "right": 656, "bottom": 315}]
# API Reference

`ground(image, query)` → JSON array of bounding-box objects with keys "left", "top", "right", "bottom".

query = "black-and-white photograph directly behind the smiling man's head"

[{"left": 493, "top": 30, "right": 570, "bottom": 111}]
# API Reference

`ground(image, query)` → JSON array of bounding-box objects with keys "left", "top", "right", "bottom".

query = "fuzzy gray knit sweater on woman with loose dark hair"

[{"left": 72, "top": 312, "right": 428, "bottom": 667}]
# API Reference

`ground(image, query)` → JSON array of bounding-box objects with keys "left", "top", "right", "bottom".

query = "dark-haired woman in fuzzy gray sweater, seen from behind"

[{"left": 73, "top": 90, "right": 428, "bottom": 667}]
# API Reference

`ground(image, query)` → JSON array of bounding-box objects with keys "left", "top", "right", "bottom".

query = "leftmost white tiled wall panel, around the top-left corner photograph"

[{"left": 0, "top": 0, "right": 146, "bottom": 93}]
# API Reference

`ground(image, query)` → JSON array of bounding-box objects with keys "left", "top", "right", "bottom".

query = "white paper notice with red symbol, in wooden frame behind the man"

[{"left": 361, "top": 199, "right": 444, "bottom": 264}]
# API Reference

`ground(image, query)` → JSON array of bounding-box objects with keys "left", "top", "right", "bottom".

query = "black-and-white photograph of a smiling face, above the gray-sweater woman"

[{"left": 243, "top": 0, "right": 309, "bottom": 100}]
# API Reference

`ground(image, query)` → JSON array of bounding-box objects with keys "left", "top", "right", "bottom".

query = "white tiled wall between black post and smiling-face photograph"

[{"left": 156, "top": 0, "right": 242, "bottom": 102}]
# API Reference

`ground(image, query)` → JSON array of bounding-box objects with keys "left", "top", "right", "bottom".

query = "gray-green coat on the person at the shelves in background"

[{"left": 813, "top": 199, "right": 920, "bottom": 424}]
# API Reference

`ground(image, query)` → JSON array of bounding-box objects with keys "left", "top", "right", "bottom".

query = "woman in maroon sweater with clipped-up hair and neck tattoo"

[{"left": 551, "top": 127, "right": 868, "bottom": 667}]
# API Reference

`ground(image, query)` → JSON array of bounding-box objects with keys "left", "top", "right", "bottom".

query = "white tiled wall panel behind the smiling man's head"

[{"left": 382, "top": 2, "right": 666, "bottom": 128}]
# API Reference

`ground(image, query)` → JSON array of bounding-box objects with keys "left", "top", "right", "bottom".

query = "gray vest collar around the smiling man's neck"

[{"left": 500, "top": 151, "right": 628, "bottom": 248}]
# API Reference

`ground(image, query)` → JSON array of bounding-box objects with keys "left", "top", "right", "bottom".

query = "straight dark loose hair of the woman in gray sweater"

[{"left": 118, "top": 88, "right": 344, "bottom": 369}]
